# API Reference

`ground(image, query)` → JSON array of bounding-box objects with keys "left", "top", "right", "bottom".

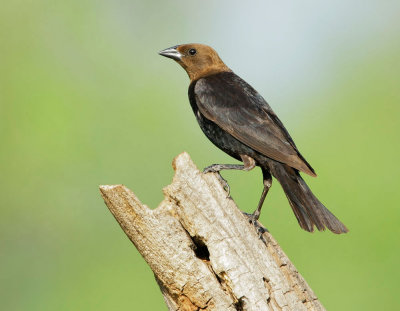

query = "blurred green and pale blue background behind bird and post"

[{"left": 0, "top": 0, "right": 400, "bottom": 311}]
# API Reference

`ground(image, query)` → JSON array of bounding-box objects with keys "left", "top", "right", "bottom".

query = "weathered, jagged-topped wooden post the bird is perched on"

[{"left": 100, "top": 153, "right": 325, "bottom": 311}]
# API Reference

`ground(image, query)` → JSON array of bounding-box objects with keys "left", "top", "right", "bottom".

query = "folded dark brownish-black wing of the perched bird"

[{"left": 194, "top": 72, "right": 316, "bottom": 176}]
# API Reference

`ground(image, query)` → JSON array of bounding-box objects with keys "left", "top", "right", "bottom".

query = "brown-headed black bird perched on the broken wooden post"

[{"left": 159, "top": 43, "right": 348, "bottom": 234}]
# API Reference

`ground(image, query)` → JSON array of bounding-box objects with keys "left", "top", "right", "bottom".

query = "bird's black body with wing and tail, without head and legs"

[{"left": 188, "top": 72, "right": 347, "bottom": 233}]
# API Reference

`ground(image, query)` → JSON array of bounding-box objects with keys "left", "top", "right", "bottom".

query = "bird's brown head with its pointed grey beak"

[{"left": 159, "top": 43, "right": 231, "bottom": 81}]
